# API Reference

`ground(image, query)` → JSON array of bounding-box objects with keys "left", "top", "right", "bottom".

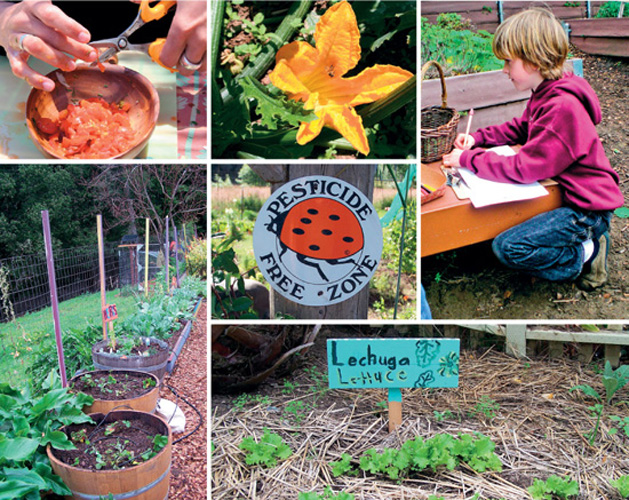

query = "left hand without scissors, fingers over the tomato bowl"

[{"left": 0, "top": 0, "right": 97, "bottom": 92}]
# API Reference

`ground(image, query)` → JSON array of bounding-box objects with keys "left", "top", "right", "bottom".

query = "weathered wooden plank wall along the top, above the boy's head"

[{"left": 420, "top": 0, "right": 605, "bottom": 33}]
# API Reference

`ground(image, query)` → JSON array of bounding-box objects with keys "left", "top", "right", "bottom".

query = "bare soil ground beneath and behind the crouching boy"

[{"left": 421, "top": 49, "right": 629, "bottom": 319}]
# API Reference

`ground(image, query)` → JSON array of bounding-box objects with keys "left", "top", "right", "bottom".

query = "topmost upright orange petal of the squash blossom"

[{"left": 315, "top": 1, "right": 360, "bottom": 76}]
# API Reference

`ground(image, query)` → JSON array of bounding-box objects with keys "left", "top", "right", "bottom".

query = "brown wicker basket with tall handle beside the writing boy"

[{"left": 421, "top": 61, "right": 459, "bottom": 163}]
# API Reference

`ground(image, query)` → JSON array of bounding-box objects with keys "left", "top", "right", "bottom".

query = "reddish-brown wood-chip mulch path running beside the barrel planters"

[{"left": 160, "top": 302, "right": 207, "bottom": 500}]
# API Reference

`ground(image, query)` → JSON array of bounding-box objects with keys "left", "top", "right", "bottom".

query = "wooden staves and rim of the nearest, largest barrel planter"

[{"left": 47, "top": 410, "right": 172, "bottom": 500}]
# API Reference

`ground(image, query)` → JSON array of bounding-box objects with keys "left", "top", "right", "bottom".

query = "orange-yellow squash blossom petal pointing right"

[{"left": 343, "top": 64, "right": 413, "bottom": 106}]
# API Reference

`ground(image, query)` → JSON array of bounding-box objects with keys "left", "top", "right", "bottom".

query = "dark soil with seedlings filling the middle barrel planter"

[{"left": 72, "top": 371, "right": 156, "bottom": 400}]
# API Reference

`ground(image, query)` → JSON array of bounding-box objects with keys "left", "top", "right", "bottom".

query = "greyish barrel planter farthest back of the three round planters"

[{"left": 92, "top": 337, "right": 169, "bottom": 382}]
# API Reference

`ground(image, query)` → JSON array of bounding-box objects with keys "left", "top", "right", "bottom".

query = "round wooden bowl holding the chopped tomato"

[{"left": 26, "top": 63, "right": 159, "bottom": 159}]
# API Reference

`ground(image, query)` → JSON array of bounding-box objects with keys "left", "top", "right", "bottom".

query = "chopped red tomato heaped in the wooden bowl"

[{"left": 37, "top": 97, "right": 136, "bottom": 158}]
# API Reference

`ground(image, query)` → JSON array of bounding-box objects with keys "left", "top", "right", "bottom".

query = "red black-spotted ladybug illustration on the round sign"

[{"left": 266, "top": 198, "right": 365, "bottom": 281}]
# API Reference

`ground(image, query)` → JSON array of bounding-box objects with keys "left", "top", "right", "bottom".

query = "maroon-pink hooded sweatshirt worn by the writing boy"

[{"left": 460, "top": 73, "right": 623, "bottom": 210}]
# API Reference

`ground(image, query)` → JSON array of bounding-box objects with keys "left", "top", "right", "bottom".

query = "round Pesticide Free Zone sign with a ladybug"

[{"left": 253, "top": 175, "right": 382, "bottom": 306}]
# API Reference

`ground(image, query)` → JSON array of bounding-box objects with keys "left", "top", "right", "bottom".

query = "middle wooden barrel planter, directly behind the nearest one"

[{"left": 70, "top": 370, "right": 159, "bottom": 414}]
